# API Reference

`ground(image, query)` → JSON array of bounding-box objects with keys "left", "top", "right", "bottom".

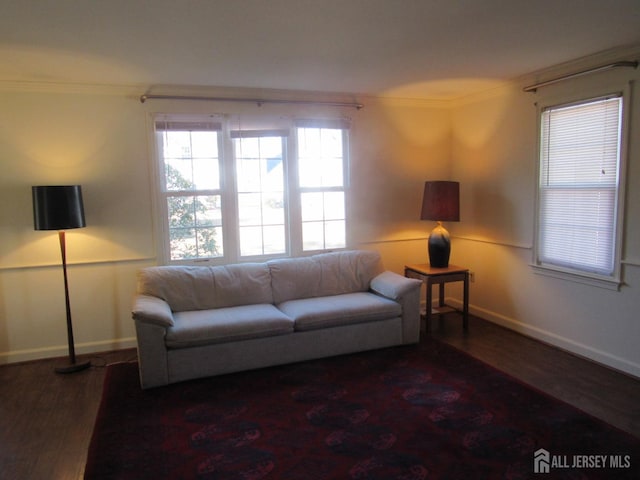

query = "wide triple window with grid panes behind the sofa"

[{"left": 154, "top": 115, "right": 348, "bottom": 263}]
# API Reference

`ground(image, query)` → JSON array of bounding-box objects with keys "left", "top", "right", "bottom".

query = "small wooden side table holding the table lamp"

[{"left": 404, "top": 263, "right": 469, "bottom": 331}]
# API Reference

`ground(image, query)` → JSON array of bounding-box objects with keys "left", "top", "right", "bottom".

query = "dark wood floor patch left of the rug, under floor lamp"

[{"left": 0, "top": 349, "right": 136, "bottom": 480}]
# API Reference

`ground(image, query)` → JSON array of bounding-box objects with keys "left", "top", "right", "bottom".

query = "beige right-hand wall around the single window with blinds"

[{"left": 452, "top": 47, "right": 640, "bottom": 376}]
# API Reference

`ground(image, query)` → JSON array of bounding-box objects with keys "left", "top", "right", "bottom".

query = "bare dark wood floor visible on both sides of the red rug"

[{"left": 0, "top": 314, "right": 640, "bottom": 480}]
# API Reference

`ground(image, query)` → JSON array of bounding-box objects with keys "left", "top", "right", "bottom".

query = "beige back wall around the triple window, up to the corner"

[{"left": 0, "top": 84, "right": 450, "bottom": 363}]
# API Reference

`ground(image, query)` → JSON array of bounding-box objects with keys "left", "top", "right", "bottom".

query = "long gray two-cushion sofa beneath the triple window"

[{"left": 132, "top": 250, "right": 421, "bottom": 388}]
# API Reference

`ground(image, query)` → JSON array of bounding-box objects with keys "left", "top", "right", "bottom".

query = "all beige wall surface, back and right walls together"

[{"left": 0, "top": 46, "right": 640, "bottom": 376}]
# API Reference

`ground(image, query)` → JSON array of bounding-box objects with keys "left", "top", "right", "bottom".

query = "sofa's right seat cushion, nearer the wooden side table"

[{"left": 278, "top": 292, "right": 402, "bottom": 332}]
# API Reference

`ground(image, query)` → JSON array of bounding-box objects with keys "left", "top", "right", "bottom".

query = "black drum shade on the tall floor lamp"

[{"left": 31, "top": 185, "right": 86, "bottom": 230}]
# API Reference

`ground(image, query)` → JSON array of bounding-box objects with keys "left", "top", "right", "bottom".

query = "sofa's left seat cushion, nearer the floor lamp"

[{"left": 165, "top": 304, "right": 293, "bottom": 348}]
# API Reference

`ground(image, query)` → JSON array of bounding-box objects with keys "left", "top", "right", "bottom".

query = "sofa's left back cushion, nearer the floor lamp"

[{"left": 138, "top": 263, "right": 273, "bottom": 312}]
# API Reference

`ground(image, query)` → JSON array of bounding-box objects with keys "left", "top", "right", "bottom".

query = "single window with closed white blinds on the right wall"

[{"left": 536, "top": 95, "right": 623, "bottom": 279}]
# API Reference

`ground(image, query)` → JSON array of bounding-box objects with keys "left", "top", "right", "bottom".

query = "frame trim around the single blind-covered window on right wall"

[{"left": 531, "top": 85, "right": 630, "bottom": 290}]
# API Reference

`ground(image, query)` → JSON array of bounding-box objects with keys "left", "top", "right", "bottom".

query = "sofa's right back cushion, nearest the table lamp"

[{"left": 268, "top": 250, "right": 382, "bottom": 304}]
